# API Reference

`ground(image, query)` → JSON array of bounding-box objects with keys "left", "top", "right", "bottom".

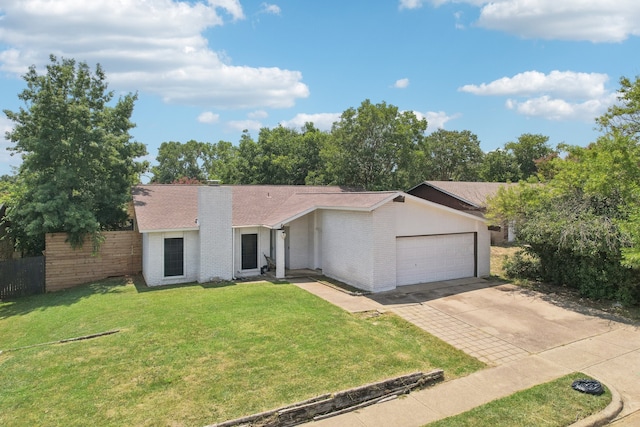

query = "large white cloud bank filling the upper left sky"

[{"left": 0, "top": 0, "right": 309, "bottom": 108}]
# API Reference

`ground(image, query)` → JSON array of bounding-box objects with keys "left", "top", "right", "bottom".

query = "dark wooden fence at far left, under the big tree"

[{"left": 0, "top": 256, "right": 45, "bottom": 299}]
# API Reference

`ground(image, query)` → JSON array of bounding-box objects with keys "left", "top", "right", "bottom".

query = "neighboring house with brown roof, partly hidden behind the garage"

[{"left": 407, "top": 181, "right": 516, "bottom": 244}]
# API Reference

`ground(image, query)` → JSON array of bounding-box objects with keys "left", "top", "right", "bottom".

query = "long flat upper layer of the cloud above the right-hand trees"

[{"left": 458, "top": 70, "right": 609, "bottom": 99}]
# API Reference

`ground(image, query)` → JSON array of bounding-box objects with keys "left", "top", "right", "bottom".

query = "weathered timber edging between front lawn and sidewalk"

[{"left": 207, "top": 369, "right": 444, "bottom": 427}]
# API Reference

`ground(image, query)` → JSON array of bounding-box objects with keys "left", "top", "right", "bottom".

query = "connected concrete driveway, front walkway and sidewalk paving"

[{"left": 295, "top": 278, "right": 640, "bottom": 427}]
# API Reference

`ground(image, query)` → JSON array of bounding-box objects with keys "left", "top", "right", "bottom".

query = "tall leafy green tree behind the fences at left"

[{"left": 4, "top": 55, "right": 148, "bottom": 253}]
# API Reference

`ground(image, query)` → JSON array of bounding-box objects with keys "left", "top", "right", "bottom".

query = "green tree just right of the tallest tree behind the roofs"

[{"left": 419, "top": 129, "right": 484, "bottom": 181}]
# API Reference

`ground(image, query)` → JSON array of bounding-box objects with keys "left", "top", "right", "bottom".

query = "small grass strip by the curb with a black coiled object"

[{"left": 428, "top": 372, "right": 611, "bottom": 427}]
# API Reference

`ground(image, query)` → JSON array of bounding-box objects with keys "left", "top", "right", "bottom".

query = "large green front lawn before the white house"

[{"left": 0, "top": 280, "right": 484, "bottom": 426}]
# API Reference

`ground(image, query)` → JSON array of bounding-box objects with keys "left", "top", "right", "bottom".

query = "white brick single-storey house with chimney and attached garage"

[{"left": 133, "top": 185, "right": 490, "bottom": 292}]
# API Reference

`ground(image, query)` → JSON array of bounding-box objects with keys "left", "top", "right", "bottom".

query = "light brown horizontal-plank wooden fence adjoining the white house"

[{"left": 45, "top": 231, "right": 142, "bottom": 292}]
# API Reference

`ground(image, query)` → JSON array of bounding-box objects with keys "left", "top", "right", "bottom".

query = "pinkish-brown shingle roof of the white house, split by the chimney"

[{"left": 132, "top": 184, "right": 399, "bottom": 231}]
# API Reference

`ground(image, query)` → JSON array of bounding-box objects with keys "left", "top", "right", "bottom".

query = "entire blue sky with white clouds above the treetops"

[{"left": 0, "top": 0, "right": 640, "bottom": 175}]
